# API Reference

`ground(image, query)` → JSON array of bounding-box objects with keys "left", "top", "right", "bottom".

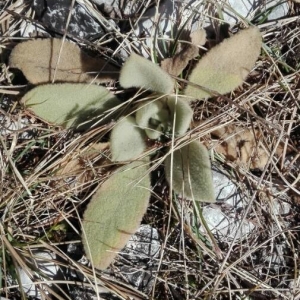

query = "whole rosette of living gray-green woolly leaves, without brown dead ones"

[{"left": 12, "top": 28, "right": 261, "bottom": 269}]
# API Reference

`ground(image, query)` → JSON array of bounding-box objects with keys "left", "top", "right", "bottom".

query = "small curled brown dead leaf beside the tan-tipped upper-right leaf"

[{"left": 161, "top": 29, "right": 206, "bottom": 76}]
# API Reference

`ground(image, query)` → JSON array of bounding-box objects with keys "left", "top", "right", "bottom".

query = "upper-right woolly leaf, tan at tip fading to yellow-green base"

[{"left": 185, "top": 27, "right": 262, "bottom": 99}]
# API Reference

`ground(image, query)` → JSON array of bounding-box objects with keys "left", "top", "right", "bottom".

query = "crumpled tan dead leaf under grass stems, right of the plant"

[{"left": 212, "top": 125, "right": 283, "bottom": 170}]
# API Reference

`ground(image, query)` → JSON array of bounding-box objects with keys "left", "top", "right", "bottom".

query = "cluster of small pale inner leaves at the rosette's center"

[{"left": 110, "top": 53, "right": 193, "bottom": 161}]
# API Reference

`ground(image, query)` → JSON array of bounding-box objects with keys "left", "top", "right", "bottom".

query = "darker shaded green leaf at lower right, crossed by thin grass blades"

[{"left": 165, "top": 141, "right": 215, "bottom": 202}]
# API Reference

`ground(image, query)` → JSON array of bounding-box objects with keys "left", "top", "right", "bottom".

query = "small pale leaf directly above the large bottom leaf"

[{"left": 110, "top": 116, "right": 146, "bottom": 161}]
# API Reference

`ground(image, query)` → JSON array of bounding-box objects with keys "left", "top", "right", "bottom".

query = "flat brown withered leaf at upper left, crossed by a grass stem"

[{"left": 9, "top": 38, "right": 118, "bottom": 84}]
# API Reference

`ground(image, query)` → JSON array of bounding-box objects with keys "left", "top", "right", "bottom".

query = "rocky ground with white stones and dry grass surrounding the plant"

[{"left": 0, "top": 0, "right": 300, "bottom": 300}]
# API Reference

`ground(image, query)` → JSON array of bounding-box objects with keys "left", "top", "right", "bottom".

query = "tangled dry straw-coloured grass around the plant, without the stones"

[{"left": 0, "top": 0, "right": 300, "bottom": 300}]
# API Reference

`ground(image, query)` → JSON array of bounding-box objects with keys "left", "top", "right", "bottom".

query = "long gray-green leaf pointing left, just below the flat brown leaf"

[{"left": 21, "top": 83, "right": 120, "bottom": 130}]
